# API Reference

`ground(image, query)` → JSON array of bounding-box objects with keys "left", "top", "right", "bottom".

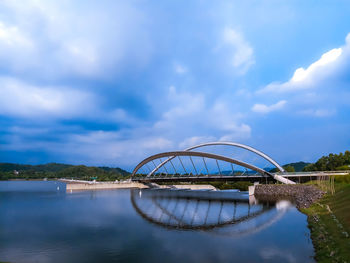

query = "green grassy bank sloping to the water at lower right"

[{"left": 302, "top": 180, "right": 350, "bottom": 262}]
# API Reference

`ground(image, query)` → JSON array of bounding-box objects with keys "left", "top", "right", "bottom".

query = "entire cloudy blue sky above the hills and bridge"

[{"left": 0, "top": 0, "right": 350, "bottom": 170}]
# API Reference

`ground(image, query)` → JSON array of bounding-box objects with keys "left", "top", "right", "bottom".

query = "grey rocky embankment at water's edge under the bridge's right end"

[{"left": 254, "top": 184, "right": 325, "bottom": 209}]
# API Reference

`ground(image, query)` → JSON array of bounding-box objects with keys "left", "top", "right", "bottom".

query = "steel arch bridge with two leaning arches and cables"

[{"left": 131, "top": 142, "right": 295, "bottom": 184}]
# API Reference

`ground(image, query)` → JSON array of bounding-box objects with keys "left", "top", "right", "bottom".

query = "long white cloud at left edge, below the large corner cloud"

[{"left": 0, "top": 76, "right": 150, "bottom": 126}]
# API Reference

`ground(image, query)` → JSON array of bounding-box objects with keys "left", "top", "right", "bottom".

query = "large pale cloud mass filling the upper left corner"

[{"left": 0, "top": 0, "right": 152, "bottom": 79}]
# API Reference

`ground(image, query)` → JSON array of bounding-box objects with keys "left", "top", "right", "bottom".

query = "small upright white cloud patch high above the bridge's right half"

[{"left": 219, "top": 27, "right": 255, "bottom": 74}]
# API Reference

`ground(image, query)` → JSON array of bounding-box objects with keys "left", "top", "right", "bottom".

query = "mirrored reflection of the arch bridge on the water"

[{"left": 131, "top": 190, "right": 291, "bottom": 236}]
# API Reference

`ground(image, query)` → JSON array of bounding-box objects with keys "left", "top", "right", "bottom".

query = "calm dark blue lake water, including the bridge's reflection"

[{"left": 0, "top": 181, "right": 314, "bottom": 262}]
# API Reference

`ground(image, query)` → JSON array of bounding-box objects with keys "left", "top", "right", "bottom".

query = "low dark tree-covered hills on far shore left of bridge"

[{"left": 0, "top": 163, "right": 130, "bottom": 181}]
